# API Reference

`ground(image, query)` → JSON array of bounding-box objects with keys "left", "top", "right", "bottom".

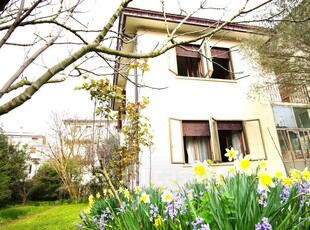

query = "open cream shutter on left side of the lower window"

[{"left": 169, "top": 118, "right": 185, "bottom": 164}]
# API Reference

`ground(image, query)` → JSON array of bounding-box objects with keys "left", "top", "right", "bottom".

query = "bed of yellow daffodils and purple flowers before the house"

[{"left": 80, "top": 151, "right": 310, "bottom": 230}]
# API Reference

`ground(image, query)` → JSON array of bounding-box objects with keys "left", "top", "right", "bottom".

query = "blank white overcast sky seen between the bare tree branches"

[{"left": 0, "top": 0, "right": 266, "bottom": 134}]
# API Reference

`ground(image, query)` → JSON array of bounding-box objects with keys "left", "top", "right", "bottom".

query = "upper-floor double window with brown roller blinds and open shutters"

[{"left": 169, "top": 42, "right": 234, "bottom": 80}]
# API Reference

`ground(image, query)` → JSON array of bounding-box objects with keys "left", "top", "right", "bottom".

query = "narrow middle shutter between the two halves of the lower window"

[{"left": 209, "top": 117, "right": 222, "bottom": 162}]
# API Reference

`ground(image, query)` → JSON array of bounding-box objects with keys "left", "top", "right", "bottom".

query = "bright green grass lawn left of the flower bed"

[{"left": 0, "top": 204, "right": 87, "bottom": 230}]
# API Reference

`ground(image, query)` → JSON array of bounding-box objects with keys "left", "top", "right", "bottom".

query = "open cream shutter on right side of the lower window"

[{"left": 243, "top": 119, "right": 266, "bottom": 160}]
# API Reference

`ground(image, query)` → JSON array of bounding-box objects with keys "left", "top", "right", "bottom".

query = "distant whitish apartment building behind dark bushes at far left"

[{"left": 4, "top": 132, "right": 47, "bottom": 178}]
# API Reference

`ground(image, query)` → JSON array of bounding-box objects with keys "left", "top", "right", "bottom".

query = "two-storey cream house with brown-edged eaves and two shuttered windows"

[{"left": 113, "top": 8, "right": 285, "bottom": 185}]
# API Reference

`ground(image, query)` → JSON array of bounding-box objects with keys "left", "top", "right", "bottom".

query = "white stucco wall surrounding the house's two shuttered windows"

[{"left": 126, "top": 31, "right": 284, "bottom": 186}]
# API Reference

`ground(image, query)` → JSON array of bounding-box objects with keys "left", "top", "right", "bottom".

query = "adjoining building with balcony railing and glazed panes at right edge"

[{"left": 270, "top": 85, "right": 310, "bottom": 170}]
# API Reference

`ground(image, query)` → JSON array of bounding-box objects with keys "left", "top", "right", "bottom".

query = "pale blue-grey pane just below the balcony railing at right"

[{"left": 272, "top": 105, "right": 297, "bottom": 128}]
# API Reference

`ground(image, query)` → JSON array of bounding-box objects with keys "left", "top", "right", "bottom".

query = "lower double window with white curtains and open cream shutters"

[{"left": 170, "top": 118, "right": 266, "bottom": 164}]
